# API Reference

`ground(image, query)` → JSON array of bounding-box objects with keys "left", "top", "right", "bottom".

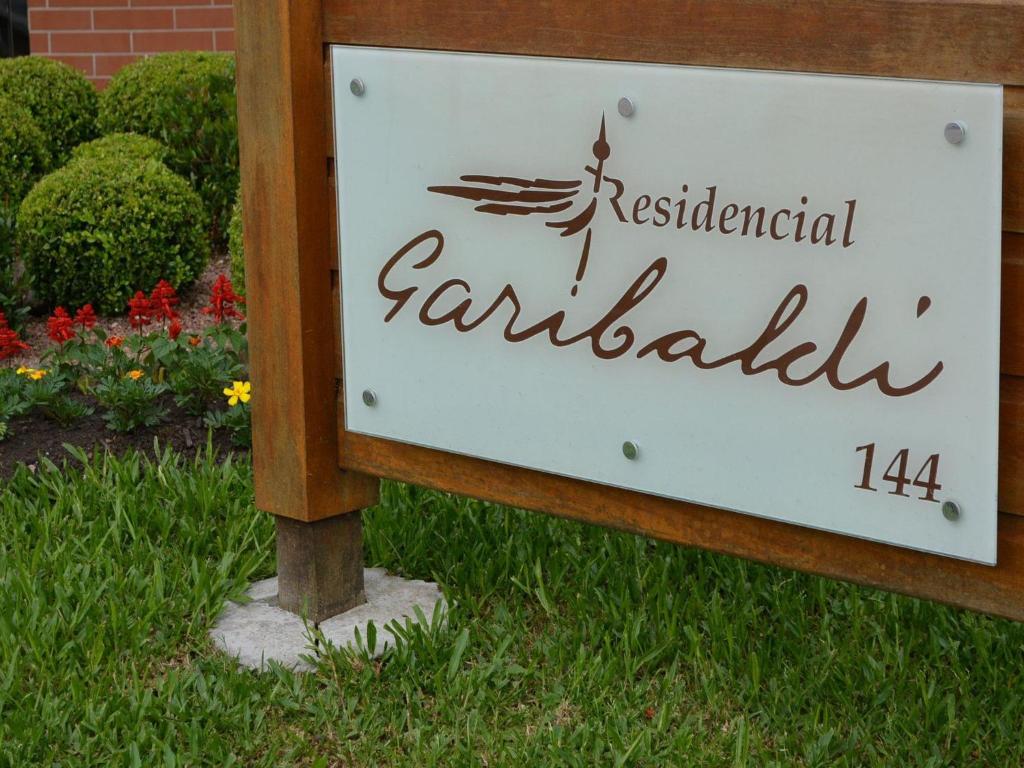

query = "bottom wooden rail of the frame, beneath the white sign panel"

[{"left": 341, "top": 423, "right": 1024, "bottom": 621}]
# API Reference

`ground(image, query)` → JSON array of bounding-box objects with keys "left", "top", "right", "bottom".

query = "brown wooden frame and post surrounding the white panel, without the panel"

[{"left": 237, "top": 0, "right": 1024, "bottom": 621}]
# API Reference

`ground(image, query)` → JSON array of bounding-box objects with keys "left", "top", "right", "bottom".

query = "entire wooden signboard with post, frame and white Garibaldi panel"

[{"left": 238, "top": 0, "right": 1024, "bottom": 618}]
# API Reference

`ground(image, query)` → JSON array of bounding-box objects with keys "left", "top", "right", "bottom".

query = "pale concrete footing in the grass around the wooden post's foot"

[{"left": 210, "top": 568, "right": 444, "bottom": 672}]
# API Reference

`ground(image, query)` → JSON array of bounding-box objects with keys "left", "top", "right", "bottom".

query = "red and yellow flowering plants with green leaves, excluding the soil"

[{"left": 0, "top": 275, "right": 251, "bottom": 447}]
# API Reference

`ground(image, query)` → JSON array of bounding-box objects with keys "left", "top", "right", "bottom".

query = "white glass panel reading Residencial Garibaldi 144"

[{"left": 332, "top": 46, "right": 1002, "bottom": 563}]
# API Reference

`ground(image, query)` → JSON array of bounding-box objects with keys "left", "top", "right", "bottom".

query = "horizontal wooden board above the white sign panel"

[{"left": 324, "top": 0, "right": 1024, "bottom": 85}]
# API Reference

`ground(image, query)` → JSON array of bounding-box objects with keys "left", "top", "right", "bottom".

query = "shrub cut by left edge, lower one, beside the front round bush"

[{"left": 0, "top": 96, "right": 50, "bottom": 268}]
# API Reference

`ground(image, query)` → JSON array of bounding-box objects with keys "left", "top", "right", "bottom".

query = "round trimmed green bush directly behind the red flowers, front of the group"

[{"left": 17, "top": 158, "right": 209, "bottom": 314}]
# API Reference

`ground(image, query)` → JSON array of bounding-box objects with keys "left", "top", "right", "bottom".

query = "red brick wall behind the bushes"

[{"left": 29, "top": 0, "right": 234, "bottom": 88}]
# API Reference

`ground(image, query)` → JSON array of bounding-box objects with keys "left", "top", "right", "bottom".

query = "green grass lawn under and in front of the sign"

[{"left": 0, "top": 455, "right": 1024, "bottom": 768}]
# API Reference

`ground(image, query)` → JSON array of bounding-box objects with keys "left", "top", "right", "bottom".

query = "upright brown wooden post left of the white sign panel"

[{"left": 236, "top": 0, "right": 378, "bottom": 621}]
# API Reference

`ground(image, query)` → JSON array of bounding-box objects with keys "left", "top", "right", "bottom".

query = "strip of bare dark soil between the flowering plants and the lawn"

[{"left": 0, "top": 396, "right": 249, "bottom": 479}]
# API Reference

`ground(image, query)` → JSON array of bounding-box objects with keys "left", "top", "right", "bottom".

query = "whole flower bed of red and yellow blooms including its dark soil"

[{"left": 0, "top": 275, "right": 251, "bottom": 475}]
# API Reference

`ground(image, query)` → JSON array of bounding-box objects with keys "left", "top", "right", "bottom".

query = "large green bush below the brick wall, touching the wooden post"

[{"left": 99, "top": 51, "right": 239, "bottom": 247}]
